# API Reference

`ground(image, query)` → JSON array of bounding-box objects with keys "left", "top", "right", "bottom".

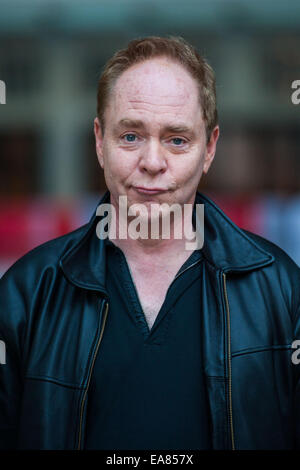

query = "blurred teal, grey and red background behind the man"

[{"left": 0, "top": 0, "right": 300, "bottom": 276}]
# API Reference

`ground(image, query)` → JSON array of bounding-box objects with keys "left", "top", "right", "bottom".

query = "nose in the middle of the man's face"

[{"left": 140, "top": 139, "right": 167, "bottom": 175}]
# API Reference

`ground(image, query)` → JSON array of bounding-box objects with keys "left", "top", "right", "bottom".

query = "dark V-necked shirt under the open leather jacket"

[{"left": 85, "top": 240, "right": 211, "bottom": 450}]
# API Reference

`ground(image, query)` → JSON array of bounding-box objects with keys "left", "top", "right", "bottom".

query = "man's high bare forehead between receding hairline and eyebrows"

[{"left": 108, "top": 57, "right": 200, "bottom": 119}]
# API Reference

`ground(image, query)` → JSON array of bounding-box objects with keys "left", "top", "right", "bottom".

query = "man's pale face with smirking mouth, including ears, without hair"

[{"left": 94, "top": 58, "right": 219, "bottom": 213}]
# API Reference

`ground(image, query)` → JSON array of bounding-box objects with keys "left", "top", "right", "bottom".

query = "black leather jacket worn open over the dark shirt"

[{"left": 0, "top": 193, "right": 300, "bottom": 449}]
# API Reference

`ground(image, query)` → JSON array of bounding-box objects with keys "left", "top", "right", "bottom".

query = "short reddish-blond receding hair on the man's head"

[{"left": 97, "top": 36, "right": 218, "bottom": 140}]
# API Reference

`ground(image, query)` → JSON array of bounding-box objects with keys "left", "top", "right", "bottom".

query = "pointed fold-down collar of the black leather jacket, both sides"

[{"left": 60, "top": 191, "right": 274, "bottom": 294}]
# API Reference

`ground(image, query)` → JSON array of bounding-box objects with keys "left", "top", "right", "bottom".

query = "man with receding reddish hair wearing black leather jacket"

[{"left": 0, "top": 37, "right": 300, "bottom": 450}]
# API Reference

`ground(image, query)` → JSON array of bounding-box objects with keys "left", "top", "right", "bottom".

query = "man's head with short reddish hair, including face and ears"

[{"left": 94, "top": 37, "right": 219, "bottom": 213}]
